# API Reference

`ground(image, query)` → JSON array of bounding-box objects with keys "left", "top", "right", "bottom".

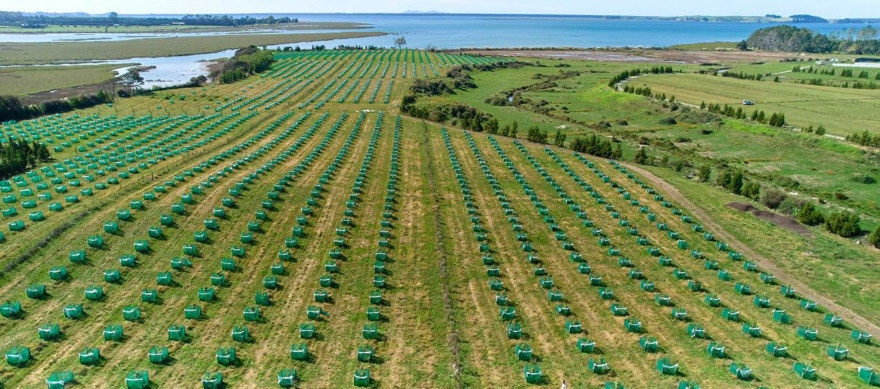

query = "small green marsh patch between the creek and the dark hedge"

[{"left": 0, "top": 65, "right": 125, "bottom": 96}]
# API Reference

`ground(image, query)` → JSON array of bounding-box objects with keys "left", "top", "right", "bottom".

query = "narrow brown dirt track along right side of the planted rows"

[{"left": 621, "top": 163, "right": 880, "bottom": 334}]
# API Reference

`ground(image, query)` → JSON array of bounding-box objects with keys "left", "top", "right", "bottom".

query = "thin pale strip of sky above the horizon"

[{"left": 6, "top": 0, "right": 880, "bottom": 18}]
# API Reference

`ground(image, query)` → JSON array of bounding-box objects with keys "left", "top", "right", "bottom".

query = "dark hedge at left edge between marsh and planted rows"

[{"left": 0, "top": 90, "right": 113, "bottom": 122}]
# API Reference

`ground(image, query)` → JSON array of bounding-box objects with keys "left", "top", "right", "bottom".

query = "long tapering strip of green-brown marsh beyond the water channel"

[{"left": 0, "top": 32, "right": 384, "bottom": 65}]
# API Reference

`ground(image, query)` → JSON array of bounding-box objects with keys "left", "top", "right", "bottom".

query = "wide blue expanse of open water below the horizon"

[{"left": 280, "top": 14, "right": 866, "bottom": 49}]
